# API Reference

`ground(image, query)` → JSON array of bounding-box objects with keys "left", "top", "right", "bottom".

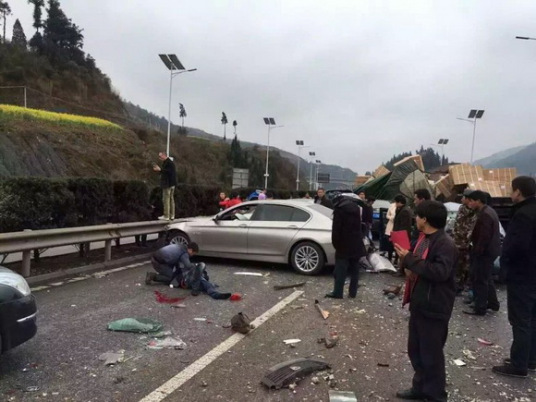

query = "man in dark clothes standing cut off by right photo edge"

[{"left": 492, "top": 176, "right": 536, "bottom": 377}]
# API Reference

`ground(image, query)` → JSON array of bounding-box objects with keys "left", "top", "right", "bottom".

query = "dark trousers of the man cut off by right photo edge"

[{"left": 506, "top": 283, "right": 536, "bottom": 370}]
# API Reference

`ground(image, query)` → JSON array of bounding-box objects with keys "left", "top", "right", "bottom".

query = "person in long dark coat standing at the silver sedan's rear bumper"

[{"left": 326, "top": 194, "right": 366, "bottom": 299}]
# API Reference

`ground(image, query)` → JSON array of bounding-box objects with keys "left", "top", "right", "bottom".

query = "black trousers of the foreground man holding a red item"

[{"left": 408, "top": 311, "right": 449, "bottom": 402}]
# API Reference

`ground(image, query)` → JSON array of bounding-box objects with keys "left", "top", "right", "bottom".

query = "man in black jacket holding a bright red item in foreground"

[{"left": 395, "top": 201, "right": 458, "bottom": 402}]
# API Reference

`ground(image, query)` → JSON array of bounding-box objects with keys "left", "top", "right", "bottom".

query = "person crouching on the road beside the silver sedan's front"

[{"left": 145, "top": 242, "right": 199, "bottom": 287}]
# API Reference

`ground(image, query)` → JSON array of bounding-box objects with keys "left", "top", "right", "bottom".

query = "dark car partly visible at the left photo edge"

[{"left": 0, "top": 266, "right": 37, "bottom": 353}]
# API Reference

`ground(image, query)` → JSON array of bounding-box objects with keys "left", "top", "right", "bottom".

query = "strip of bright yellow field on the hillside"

[{"left": 0, "top": 104, "right": 123, "bottom": 130}]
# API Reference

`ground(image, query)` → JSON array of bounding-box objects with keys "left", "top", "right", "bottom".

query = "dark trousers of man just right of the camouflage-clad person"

[{"left": 471, "top": 256, "right": 499, "bottom": 313}]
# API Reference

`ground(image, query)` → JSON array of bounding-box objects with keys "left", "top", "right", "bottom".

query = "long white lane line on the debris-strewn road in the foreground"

[{"left": 140, "top": 290, "right": 303, "bottom": 402}]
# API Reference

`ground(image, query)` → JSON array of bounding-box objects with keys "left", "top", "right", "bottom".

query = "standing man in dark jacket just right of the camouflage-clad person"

[{"left": 464, "top": 190, "right": 501, "bottom": 315}]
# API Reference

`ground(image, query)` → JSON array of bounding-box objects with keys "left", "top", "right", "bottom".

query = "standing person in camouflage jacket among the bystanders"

[{"left": 452, "top": 189, "right": 476, "bottom": 292}]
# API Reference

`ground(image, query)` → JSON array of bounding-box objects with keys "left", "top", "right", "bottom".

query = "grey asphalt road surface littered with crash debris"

[{"left": 0, "top": 260, "right": 536, "bottom": 402}]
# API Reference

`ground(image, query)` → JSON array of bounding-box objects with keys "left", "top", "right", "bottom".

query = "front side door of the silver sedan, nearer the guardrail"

[{"left": 199, "top": 204, "right": 256, "bottom": 258}]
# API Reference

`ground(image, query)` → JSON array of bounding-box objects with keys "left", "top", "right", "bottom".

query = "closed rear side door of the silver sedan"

[{"left": 248, "top": 203, "right": 311, "bottom": 260}]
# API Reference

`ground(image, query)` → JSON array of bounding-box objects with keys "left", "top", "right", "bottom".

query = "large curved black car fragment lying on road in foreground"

[{"left": 261, "top": 359, "right": 330, "bottom": 389}]
